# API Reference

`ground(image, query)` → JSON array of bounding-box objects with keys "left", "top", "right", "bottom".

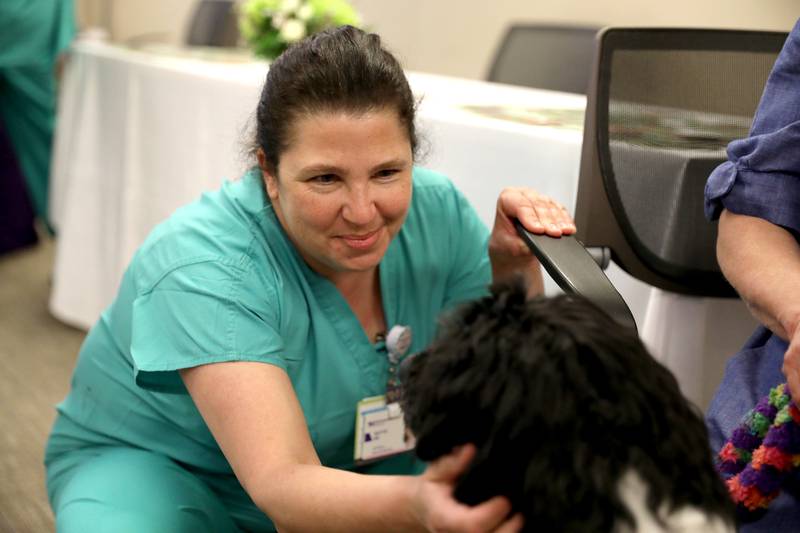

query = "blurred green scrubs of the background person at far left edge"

[{"left": 0, "top": 0, "right": 75, "bottom": 224}]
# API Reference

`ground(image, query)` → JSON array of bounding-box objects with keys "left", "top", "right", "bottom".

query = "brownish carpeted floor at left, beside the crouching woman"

[{"left": 0, "top": 240, "right": 85, "bottom": 533}]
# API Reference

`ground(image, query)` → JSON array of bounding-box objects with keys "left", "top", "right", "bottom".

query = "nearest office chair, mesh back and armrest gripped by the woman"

[{"left": 517, "top": 28, "right": 787, "bottom": 327}]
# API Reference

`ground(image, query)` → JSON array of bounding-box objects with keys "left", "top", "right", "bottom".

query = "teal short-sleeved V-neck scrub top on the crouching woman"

[{"left": 47, "top": 168, "right": 491, "bottom": 524}]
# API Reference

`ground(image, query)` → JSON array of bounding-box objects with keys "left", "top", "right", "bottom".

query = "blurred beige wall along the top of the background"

[{"left": 76, "top": 0, "right": 800, "bottom": 78}]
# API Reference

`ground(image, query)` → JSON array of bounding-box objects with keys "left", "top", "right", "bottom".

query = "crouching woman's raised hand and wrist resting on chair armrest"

[{"left": 489, "top": 188, "right": 575, "bottom": 294}]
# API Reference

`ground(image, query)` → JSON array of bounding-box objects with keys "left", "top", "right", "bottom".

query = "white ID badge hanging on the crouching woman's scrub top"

[{"left": 353, "top": 396, "right": 416, "bottom": 464}]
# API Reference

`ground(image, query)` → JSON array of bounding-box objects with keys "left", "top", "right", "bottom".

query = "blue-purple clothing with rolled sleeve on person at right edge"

[{"left": 705, "top": 20, "right": 800, "bottom": 533}]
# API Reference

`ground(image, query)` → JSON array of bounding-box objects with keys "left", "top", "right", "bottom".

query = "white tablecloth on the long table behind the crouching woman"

[{"left": 50, "top": 42, "right": 749, "bottom": 405}]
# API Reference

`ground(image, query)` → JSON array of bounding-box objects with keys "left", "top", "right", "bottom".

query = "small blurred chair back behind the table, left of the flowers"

[{"left": 186, "top": 0, "right": 239, "bottom": 47}]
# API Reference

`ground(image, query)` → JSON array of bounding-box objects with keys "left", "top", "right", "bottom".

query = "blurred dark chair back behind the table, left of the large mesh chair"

[{"left": 487, "top": 24, "right": 600, "bottom": 94}]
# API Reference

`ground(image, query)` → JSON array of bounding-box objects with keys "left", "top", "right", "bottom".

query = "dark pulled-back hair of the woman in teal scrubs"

[{"left": 255, "top": 26, "right": 417, "bottom": 172}]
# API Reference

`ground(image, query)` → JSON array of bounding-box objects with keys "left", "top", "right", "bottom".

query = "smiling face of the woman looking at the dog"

[{"left": 259, "top": 109, "right": 413, "bottom": 283}]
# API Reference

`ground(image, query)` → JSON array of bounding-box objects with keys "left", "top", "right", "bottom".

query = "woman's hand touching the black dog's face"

[{"left": 415, "top": 444, "right": 523, "bottom": 533}]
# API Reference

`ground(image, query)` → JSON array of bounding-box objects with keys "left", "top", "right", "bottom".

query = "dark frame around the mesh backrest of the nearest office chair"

[{"left": 575, "top": 28, "right": 787, "bottom": 297}]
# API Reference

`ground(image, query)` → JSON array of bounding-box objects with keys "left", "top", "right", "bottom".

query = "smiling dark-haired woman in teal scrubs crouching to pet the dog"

[{"left": 46, "top": 27, "right": 575, "bottom": 532}]
